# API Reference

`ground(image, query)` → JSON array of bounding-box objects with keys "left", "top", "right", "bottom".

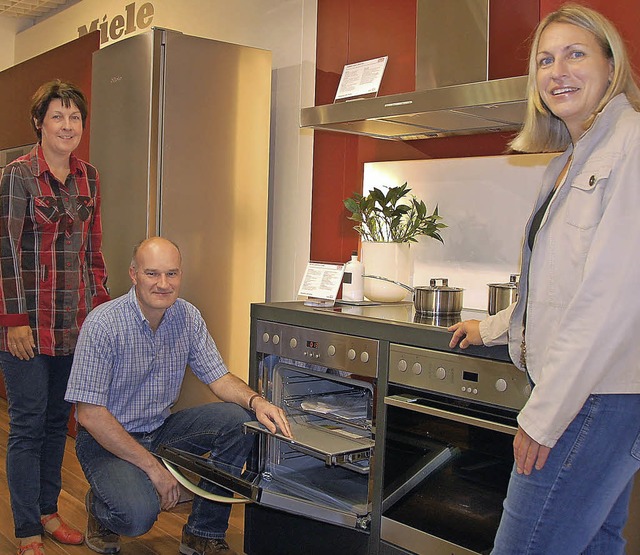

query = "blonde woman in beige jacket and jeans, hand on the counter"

[{"left": 450, "top": 4, "right": 640, "bottom": 555}]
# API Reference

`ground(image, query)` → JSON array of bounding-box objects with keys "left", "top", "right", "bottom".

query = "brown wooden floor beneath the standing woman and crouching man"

[{"left": 0, "top": 398, "right": 244, "bottom": 555}]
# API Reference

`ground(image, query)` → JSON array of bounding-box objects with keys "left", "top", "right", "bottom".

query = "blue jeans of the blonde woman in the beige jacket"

[{"left": 492, "top": 395, "right": 640, "bottom": 555}]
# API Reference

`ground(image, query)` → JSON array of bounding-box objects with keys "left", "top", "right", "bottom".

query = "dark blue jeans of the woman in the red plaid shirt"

[{"left": 0, "top": 351, "right": 73, "bottom": 538}]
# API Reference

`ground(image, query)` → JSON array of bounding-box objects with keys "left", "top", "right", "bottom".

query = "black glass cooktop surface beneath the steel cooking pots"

[{"left": 317, "top": 301, "right": 487, "bottom": 328}]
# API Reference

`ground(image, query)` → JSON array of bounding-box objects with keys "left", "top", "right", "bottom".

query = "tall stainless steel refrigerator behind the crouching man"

[{"left": 90, "top": 29, "right": 271, "bottom": 406}]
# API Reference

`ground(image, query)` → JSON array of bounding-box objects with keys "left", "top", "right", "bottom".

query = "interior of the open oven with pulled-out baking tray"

[{"left": 245, "top": 357, "right": 374, "bottom": 528}]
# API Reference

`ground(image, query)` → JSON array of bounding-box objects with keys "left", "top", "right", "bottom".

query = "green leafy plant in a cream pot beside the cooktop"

[{"left": 344, "top": 182, "right": 447, "bottom": 302}]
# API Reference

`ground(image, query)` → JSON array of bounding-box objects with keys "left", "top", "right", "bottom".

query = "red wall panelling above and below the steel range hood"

[{"left": 311, "top": 0, "right": 539, "bottom": 261}]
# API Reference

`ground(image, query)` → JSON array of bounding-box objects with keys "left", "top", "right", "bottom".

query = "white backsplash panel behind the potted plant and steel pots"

[{"left": 363, "top": 154, "right": 556, "bottom": 310}]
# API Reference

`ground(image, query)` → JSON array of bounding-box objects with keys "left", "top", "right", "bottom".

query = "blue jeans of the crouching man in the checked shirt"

[{"left": 76, "top": 403, "right": 253, "bottom": 538}]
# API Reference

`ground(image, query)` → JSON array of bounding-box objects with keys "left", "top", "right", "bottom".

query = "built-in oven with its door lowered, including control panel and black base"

[{"left": 160, "top": 320, "right": 379, "bottom": 555}]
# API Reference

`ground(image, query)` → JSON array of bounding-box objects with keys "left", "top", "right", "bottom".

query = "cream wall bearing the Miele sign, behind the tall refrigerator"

[{"left": 6, "top": 0, "right": 317, "bottom": 301}]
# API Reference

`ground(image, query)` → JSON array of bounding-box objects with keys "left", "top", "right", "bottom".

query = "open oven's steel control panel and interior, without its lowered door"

[{"left": 246, "top": 321, "right": 378, "bottom": 530}]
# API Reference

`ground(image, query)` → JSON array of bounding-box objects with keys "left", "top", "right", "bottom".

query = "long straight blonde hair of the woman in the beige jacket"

[{"left": 509, "top": 4, "right": 640, "bottom": 152}]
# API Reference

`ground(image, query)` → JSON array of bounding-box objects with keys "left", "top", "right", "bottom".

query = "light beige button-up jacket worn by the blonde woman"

[{"left": 480, "top": 95, "right": 640, "bottom": 447}]
